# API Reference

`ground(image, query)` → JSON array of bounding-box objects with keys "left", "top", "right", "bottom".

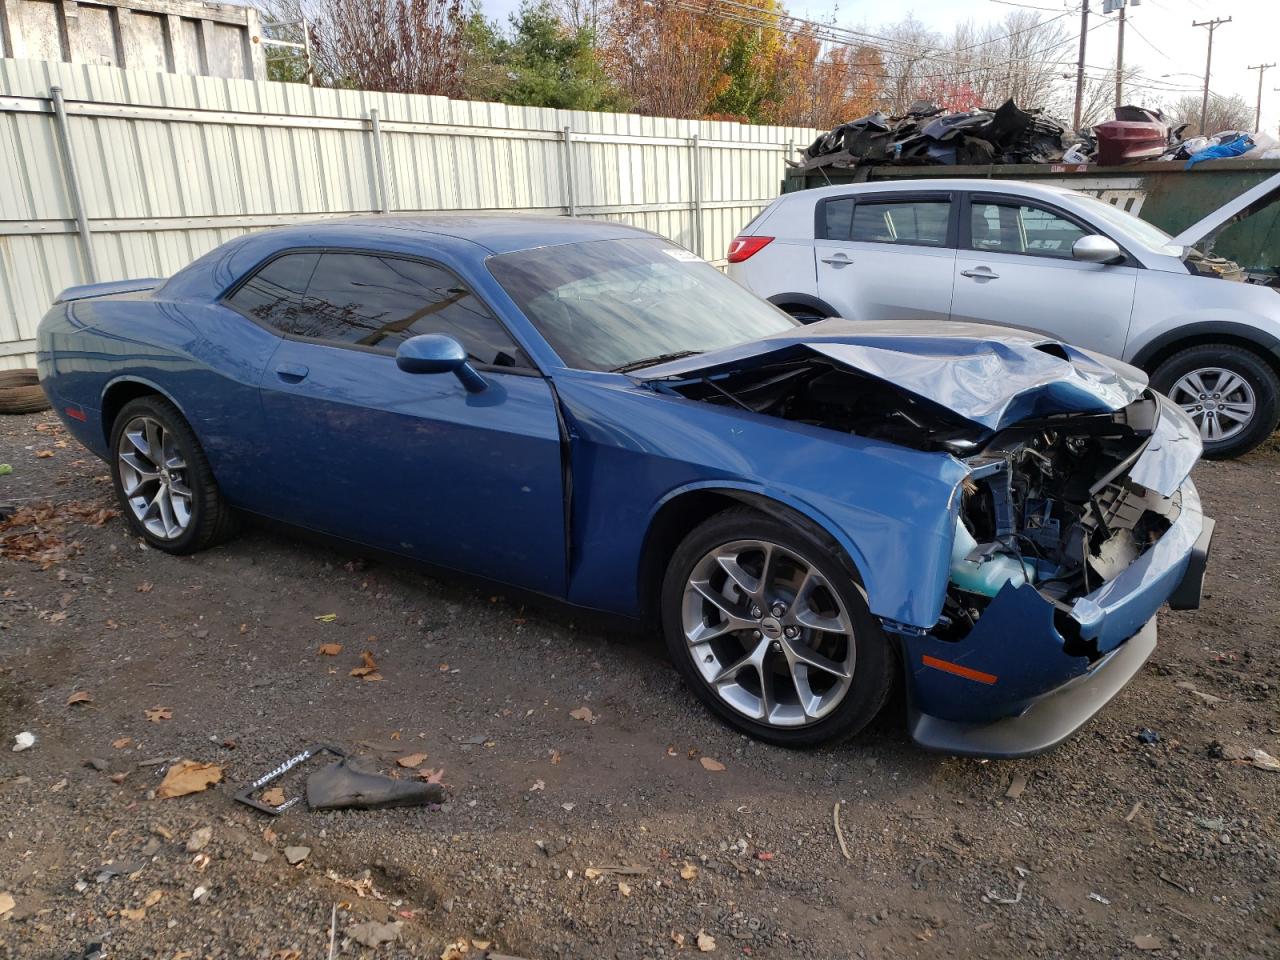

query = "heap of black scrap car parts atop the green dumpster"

[{"left": 797, "top": 100, "right": 1078, "bottom": 169}]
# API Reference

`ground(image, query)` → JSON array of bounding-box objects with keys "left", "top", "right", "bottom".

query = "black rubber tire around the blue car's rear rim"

[{"left": 109, "top": 396, "right": 237, "bottom": 554}]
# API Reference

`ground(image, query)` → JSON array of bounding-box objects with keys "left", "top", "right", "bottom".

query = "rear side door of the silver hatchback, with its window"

[{"left": 814, "top": 196, "right": 956, "bottom": 320}]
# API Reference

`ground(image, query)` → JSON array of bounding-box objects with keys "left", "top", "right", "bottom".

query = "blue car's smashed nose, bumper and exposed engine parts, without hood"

[{"left": 902, "top": 394, "right": 1213, "bottom": 755}]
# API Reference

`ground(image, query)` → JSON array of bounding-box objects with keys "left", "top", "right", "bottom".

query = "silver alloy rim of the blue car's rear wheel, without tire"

[{"left": 116, "top": 416, "right": 192, "bottom": 540}]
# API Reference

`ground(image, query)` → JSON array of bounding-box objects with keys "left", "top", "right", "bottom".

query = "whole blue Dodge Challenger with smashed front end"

[{"left": 38, "top": 216, "right": 1213, "bottom": 756}]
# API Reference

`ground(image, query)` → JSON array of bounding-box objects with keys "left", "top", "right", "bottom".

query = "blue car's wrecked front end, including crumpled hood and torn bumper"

[{"left": 654, "top": 325, "right": 1213, "bottom": 755}]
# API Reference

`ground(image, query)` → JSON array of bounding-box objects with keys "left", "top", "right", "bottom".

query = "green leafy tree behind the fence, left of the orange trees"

[{"left": 465, "top": 0, "right": 623, "bottom": 110}]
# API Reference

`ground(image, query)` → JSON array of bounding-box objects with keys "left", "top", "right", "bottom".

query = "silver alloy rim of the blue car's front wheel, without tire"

[{"left": 681, "top": 540, "right": 855, "bottom": 727}]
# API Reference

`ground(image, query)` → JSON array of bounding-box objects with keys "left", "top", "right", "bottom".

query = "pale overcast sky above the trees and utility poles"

[{"left": 481, "top": 0, "right": 1280, "bottom": 136}]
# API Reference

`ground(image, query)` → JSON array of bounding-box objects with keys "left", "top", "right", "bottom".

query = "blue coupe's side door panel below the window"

[{"left": 262, "top": 340, "right": 564, "bottom": 595}]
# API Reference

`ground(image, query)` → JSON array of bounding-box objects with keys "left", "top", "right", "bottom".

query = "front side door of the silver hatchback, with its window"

[{"left": 951, "top": 196, "right": 1138, "bottom": 357}]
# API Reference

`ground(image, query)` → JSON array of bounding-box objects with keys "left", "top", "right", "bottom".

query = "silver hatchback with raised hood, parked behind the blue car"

[{"left": 728, "top": 175, "right": 1280, "bottom": 457}]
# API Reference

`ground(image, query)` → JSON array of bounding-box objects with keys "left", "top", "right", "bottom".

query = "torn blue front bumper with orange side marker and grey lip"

[{"left": 902, "top": 442, "right": 1213, "bottom": 756}]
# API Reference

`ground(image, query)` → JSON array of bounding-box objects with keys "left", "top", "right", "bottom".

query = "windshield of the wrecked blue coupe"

[{"left": 489, "top": 238, "right": 797, "bottom": 370}]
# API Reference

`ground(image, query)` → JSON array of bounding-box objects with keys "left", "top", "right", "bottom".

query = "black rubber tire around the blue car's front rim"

[{"left": 662, "top": 507, "right": 897, "bottom": 748}]
